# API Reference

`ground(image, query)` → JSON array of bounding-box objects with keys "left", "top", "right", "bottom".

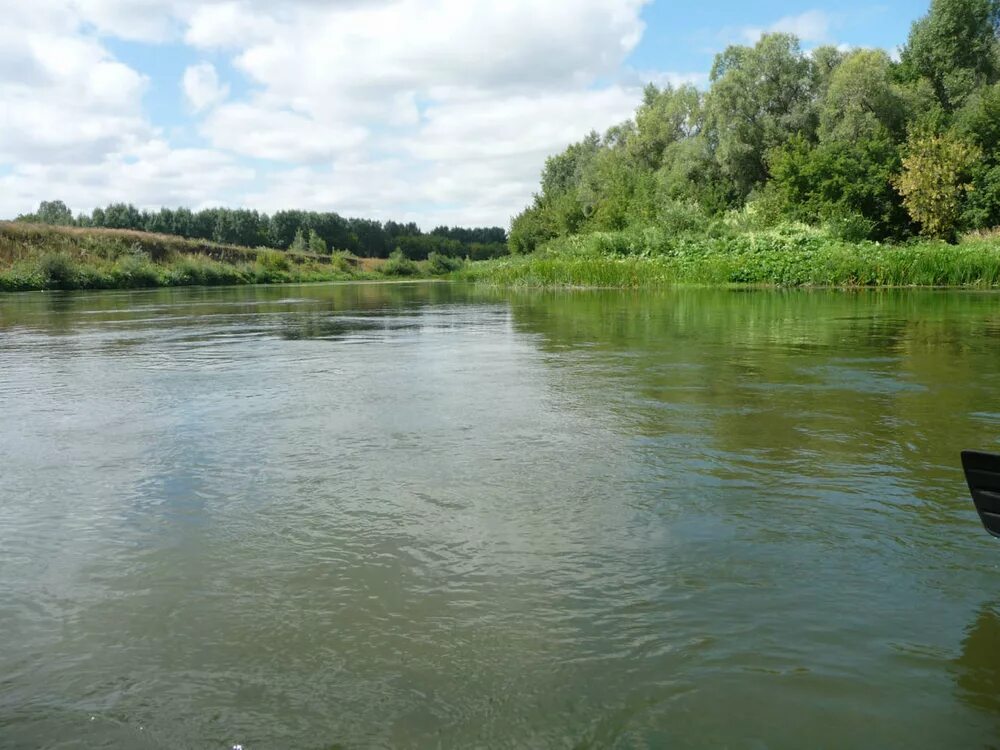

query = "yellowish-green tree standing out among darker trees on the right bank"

[{"left": 893, "top": 128, "right": 982, "bottom": 239}]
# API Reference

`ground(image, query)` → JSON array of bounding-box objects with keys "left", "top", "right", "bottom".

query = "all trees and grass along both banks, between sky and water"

[{"left": 7, "top": 0, "right": 1000, "bottom": 289}]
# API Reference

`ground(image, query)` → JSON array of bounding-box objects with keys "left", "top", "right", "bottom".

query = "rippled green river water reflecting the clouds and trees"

[{"left": 0, "top": 284, "right": 1000, "bottom": 750}]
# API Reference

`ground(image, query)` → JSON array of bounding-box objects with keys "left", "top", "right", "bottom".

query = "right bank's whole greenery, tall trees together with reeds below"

[{"left": 470, "top": 0, "right": 1000, "bottom": 286}]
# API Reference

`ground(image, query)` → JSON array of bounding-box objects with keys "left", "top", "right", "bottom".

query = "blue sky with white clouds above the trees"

[{"left": 0, "top": 0, "right": 927, "bottom": 228}]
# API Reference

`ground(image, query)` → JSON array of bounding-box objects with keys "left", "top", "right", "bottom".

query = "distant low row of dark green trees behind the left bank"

[{"left": 16, "top": 200, "right": 507, "bottom": 260}]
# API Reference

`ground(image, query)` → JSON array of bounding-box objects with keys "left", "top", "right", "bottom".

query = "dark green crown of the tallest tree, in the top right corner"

[{"left": 901, "top": 0, "right": 1000, "bottom": 112}]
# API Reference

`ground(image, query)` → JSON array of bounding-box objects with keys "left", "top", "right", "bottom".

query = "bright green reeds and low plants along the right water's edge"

[{"left": 456, "top": 225, "right": 1000, "bottom": 287}]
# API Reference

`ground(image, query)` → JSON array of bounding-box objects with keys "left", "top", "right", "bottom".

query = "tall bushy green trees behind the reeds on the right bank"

[{"left": 510, "top": 0, "right": 1000, "bottom": 252}]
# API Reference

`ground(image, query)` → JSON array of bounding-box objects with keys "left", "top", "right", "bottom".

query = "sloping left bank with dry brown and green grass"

[{"left": 0, "top": 223, "right": 444, "bottom": 291}]
